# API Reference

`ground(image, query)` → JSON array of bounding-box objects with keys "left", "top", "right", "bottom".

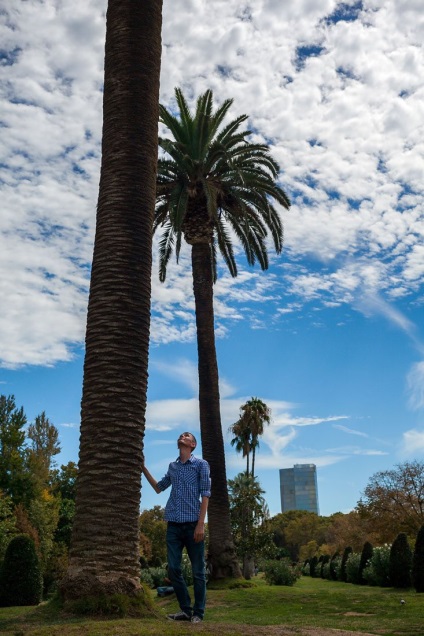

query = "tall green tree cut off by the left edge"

[{"left": 0, "top": 395, "right": 30, "bottom": 504}]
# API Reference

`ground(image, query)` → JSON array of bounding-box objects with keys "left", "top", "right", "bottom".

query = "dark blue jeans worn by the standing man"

[{"left": 166, "top": 521, "right": 206, "bottom": 618}]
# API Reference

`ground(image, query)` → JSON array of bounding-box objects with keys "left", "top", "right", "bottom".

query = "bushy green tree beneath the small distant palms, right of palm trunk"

[{"left": 228, "top": 473, "right": 270, "bottom": 579}]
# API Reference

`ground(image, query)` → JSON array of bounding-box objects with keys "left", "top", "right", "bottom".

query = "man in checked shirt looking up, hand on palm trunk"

[{"left": 143, "top": 433, "right": 211, "bottom": 623}]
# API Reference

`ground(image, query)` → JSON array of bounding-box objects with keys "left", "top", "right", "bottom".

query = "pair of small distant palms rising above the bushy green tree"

[{"left": 229, "top": 397, "right": 271, "bottom": 477}]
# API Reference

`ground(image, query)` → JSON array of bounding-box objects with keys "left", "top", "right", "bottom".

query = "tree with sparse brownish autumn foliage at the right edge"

[{"left": 358, "top": 461, "right": 424, "bottom": 542}]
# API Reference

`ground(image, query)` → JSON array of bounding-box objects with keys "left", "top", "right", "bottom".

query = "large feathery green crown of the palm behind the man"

[{"left": 154, "top": 88, "right": 290, "bottom": 281}]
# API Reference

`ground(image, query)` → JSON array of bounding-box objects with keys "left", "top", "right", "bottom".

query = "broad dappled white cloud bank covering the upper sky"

[{"left": 0, "top": 0, "right": 424, "bottom": 366}]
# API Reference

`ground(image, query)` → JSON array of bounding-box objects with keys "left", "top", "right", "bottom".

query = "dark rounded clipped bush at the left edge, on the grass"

[{"left": 0, "top": 534, "right": 43, "bottom": 607}]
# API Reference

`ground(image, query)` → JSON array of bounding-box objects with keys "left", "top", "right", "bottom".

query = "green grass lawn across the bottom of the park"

[{"left": 0, "top": 577, "right": 424, "bottom": 636}]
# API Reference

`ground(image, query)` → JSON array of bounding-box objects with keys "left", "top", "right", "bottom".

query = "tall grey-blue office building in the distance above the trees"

[{"left": 280, "top": 464, "right": 319, "bottom": 515}]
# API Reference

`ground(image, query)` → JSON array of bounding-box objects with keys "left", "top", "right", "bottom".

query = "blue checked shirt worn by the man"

[{"left": 158, "top": 455, "right": 211, "bottom": 523}]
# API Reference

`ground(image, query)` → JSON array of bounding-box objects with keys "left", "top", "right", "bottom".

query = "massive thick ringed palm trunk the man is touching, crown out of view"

[{"left": 61, "top": 0, "right": 162, "bottom": 599}]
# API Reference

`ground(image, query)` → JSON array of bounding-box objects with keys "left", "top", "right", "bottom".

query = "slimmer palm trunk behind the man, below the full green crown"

[{"left": 191, "top": 243, "right": 241, "bottom": 579}]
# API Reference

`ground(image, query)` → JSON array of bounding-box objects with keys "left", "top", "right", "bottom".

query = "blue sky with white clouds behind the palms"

[{"left": 0, "top": 0, "right": 424, "bottom": 515}]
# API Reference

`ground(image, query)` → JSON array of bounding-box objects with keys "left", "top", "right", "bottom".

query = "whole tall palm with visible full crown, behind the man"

[{"left": 154, "top": 89, "right": 289, "bottom": 578}]
